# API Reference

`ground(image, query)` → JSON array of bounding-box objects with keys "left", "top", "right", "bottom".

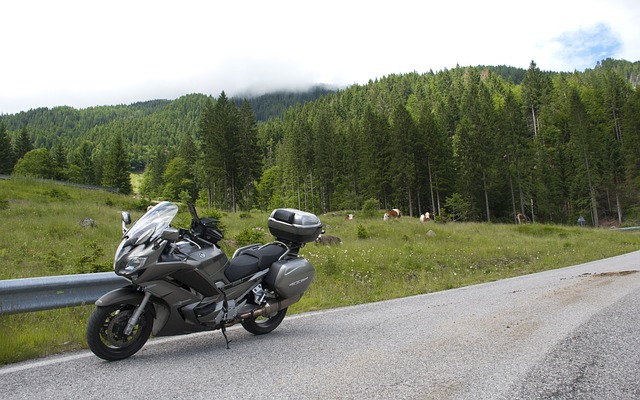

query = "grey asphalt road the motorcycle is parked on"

[{"left": 0, "top": 252, "right": 640, "bottom": 399}]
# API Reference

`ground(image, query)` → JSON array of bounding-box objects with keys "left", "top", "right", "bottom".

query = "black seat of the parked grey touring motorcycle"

[{"left": 224, "top": 243, "right": 287, "bottom": 282}]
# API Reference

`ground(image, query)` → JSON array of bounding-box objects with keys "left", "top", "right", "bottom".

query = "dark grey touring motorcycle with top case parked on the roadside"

[{"left": 86, "top": 201, "right": 322, "bottom": 361}]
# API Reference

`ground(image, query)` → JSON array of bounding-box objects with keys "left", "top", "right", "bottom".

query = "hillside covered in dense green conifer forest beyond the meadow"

[{"left": 0, "top": 59, "right": 640, "bottom": 226}]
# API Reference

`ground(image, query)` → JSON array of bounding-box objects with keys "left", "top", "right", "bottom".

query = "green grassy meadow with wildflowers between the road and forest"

[{"left": 0, "top": 179, "right": 640, "bottom": 365}]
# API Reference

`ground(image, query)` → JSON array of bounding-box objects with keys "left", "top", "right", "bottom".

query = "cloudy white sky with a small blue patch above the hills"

[{"left": 0, "top": 0, "right": 640, "bottom": 115}]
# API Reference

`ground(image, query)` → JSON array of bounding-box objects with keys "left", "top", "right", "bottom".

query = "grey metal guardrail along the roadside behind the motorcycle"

[{"left": 0, "top": 272, "right": 129, "bottom": 315}]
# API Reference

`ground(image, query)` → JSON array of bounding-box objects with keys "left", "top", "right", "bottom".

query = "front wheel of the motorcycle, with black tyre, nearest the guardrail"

[{"left": 87, "top": 304, "right": 153, "bottom": 361}]
